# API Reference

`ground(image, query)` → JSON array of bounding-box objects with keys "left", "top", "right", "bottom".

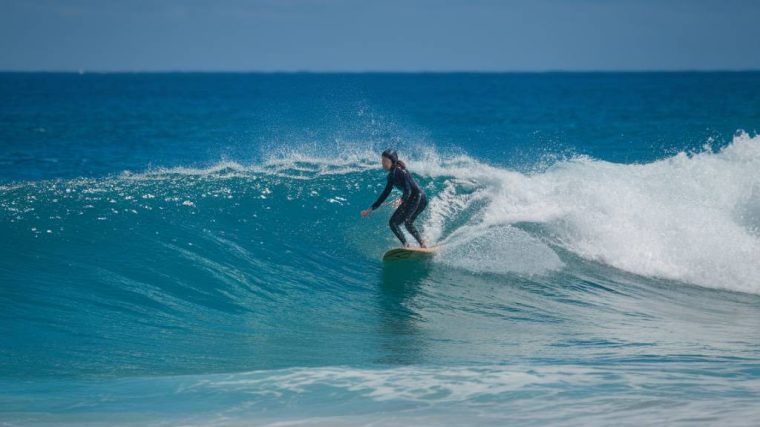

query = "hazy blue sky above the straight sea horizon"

[{"left": 0, "top": 0, "right": 760, "bottom": 71}]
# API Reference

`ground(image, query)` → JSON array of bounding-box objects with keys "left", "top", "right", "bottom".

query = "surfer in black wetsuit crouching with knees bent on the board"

[{"left": 361, "top": 149, "right": 427, "bottom": 248}]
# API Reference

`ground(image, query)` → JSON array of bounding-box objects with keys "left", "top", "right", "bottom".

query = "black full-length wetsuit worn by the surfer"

[{"left": 372, "top": 165, "right": 427, "bottom": 246}]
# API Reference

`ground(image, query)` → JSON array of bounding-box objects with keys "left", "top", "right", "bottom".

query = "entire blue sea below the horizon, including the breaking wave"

[{"left": 0, "top": 72, "right": 760, "bottom": 426}]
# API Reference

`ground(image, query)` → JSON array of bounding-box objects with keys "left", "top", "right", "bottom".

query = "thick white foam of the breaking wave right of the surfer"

[{"left": 412, "top": 134, "right": 760, "bottom": 293}]
